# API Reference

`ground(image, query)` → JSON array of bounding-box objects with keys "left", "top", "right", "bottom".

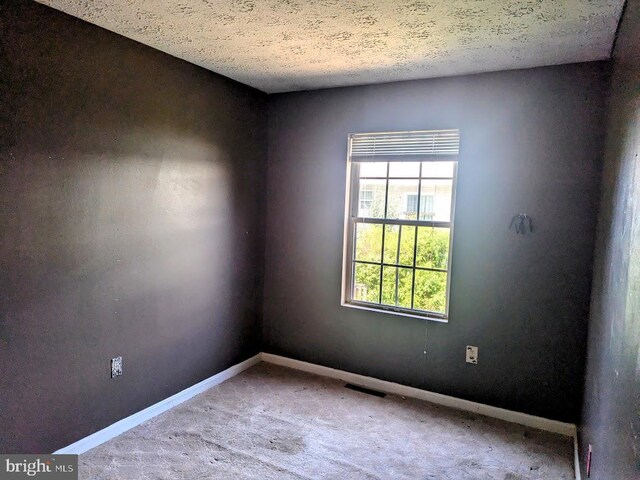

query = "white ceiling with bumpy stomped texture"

[{"left": 40, "top": 0, "right": 623, "bottom": 92}]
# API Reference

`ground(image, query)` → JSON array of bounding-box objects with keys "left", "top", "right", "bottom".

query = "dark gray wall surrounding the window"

[{"left": 264, "top": 63, "right": 607, "bottom": 421}]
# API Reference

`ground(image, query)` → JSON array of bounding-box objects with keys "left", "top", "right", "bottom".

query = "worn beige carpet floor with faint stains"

[{"left": 79, "top": 363, "right": 575, "bottom": 480}]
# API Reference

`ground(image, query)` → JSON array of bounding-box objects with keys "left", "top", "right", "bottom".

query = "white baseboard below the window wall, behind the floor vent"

[{"left": 260, "top": 352, "right": 576, "bottom": 437}]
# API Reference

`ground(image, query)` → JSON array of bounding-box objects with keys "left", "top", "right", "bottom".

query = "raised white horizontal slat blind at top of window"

[{"left": 349, "top": 129, "right": 460, "bottom": 162}]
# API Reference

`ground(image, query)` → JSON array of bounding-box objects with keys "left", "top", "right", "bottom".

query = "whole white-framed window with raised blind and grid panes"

[{"left": 342, "top": 130, "right": 459, "bottom": 321}]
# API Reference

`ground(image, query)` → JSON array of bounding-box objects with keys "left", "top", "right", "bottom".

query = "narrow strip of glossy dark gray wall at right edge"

[{"left": 580, "top": 1, "right": 640, "bottom": 480}]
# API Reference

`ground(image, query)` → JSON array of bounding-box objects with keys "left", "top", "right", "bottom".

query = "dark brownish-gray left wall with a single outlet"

[{"left": 0, "top": 0, "right": 266, "bottom": 453}]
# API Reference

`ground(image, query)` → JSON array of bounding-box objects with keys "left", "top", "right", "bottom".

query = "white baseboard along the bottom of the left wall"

[{"left": 53, "top": 354, "right": 260, "bottom": 455}]
